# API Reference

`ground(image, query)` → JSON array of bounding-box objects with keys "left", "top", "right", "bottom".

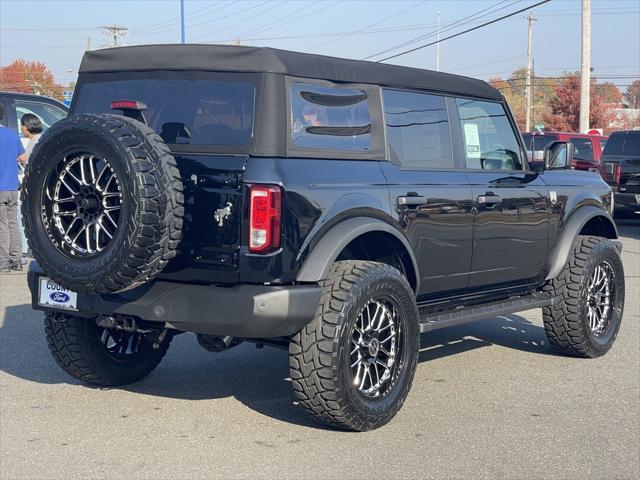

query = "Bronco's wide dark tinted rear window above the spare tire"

[{"left": 74, "top": 79, "right": 255, "bottom": 145}]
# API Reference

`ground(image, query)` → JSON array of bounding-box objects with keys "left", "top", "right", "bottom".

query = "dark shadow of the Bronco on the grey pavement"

[{"left": 0, "top": 305, "right": 550, "bottom": 428}]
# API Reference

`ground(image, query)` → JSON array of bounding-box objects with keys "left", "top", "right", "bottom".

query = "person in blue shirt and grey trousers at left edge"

[{"left": 0, "top": 104, "right": 26, "bottom": 272}]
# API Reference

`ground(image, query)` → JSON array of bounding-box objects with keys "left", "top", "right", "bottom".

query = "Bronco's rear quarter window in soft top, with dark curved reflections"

[{"left": 290, "top": 83, "right": 371, "bottom": 152}]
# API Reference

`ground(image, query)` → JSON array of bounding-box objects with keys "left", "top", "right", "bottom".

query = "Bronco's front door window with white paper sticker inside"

[{"left": 456, "top": 98, "right": 522, "bottom": 170}]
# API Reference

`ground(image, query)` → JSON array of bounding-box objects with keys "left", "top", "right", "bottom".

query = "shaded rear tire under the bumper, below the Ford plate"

[{"left": 44, "top": 312, "right": 172, "bottom": 387}]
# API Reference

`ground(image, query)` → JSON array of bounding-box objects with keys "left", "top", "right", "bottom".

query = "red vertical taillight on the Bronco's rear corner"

[{"left": 249, "top": 185, "right": 282, "bottom": 253}]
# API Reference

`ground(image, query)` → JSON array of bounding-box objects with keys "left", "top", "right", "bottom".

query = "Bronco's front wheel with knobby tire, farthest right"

[{"left": 542, "top": 236, "right": 624, "bottom": 358}]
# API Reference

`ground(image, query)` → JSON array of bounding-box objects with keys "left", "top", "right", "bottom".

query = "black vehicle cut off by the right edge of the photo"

[{"left": 600, "top": 130, "right": 640, "bottom": 214}]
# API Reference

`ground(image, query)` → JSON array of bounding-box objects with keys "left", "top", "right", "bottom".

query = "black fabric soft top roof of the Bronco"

[{"left": 80, "top": 45, "right": 502, "bottom": 100}]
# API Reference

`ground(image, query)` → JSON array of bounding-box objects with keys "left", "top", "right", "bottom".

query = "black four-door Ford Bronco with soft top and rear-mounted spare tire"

[{"left": 22, "top": 45, "right": 624, "bottom": 430}]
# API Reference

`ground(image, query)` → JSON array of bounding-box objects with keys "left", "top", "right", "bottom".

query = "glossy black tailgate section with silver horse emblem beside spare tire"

[{"left": 160, "top": 153, "right": 247, "bottom": 283}]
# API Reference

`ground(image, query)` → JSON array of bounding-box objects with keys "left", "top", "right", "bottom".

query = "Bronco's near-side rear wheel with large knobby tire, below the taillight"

[{"left": 289, "top": 261, "right": 420, "bottom": 431}]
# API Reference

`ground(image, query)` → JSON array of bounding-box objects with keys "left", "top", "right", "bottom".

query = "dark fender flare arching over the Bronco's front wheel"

[{"left": 545, "top": 205, "right": 622, "bottom": 280}]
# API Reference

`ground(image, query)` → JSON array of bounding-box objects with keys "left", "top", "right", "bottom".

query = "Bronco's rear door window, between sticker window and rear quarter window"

[{"left": 383, "top": 90, "right": 453, "bottom": 169}]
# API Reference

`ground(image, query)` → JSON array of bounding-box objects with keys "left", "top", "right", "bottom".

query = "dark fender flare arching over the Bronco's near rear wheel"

[{"left": 296, "top": 217, "right": 420, "bottom": 292}]
